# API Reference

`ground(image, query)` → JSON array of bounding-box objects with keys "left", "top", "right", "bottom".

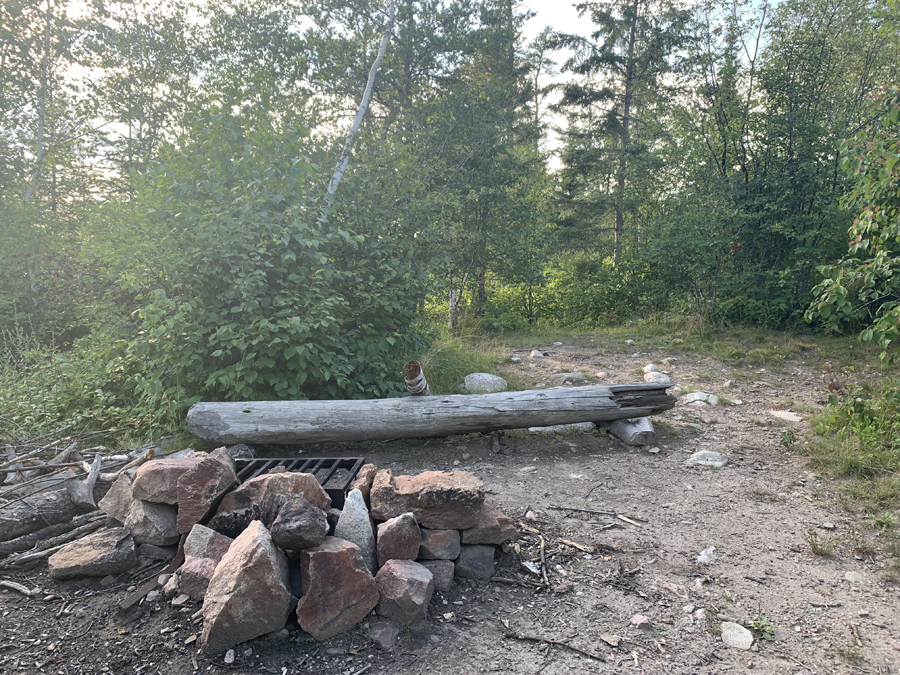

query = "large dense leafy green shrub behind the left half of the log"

[{"left": 93, "top": 106, "right": 422, "bottom": 412}]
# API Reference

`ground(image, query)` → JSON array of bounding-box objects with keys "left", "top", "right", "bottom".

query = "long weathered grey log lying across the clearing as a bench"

[{"left": 187, "top": 383, "right": 675, "bottom": 444}]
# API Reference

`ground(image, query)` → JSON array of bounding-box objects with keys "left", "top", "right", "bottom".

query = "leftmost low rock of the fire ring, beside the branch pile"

[{"left": 47, "top": 527, "right": 137, "bottom": 581}]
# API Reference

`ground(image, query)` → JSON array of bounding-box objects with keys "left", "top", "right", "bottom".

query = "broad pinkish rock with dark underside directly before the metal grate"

[{"left": 209, "top": 472, "right": 331, "bottom": 537}]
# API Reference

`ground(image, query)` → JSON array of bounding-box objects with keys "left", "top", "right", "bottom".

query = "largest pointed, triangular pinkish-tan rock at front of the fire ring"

[{"left": 202, "top": 520, "right": 296, "bottom": 654}]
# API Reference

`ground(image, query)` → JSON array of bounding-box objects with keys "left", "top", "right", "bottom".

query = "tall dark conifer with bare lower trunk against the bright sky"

[{"left": 556, "top": 0, "right": 686, "bottom": 265}]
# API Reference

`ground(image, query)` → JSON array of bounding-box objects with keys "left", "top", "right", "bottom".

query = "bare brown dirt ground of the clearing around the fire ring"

[{"left": 0, "top": 337, "right": 900, "bottom": 675}]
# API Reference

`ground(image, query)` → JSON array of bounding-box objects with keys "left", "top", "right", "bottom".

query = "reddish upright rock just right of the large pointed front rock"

[{"left": 297, "top": 537, "right": 378, "bottom": 640}]
